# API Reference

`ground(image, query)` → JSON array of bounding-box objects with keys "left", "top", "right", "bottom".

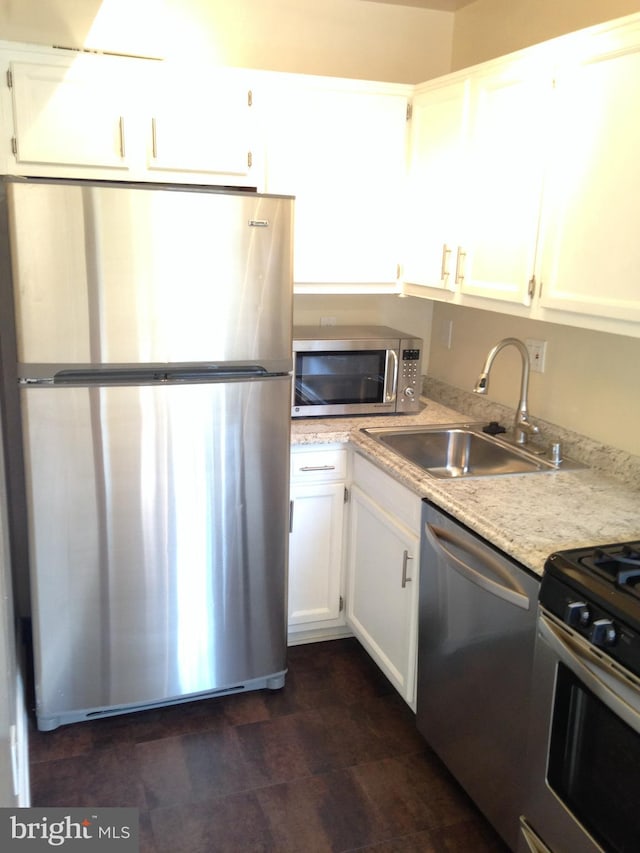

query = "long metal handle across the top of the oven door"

[{"left": 538, "top": 610, "right": 640, "bottom": 734}]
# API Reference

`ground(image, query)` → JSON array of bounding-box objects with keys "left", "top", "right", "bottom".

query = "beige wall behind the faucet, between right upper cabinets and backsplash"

[{"left": 428, "top": 303, "right": 640, "bottom": 455}]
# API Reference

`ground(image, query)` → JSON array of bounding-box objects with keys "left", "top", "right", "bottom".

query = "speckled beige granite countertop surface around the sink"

[{"left": 291, "top": 398, "right": 640, "bottom": 575}]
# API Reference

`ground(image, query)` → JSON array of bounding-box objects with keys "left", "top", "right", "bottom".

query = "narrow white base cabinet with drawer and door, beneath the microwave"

[{"left": 287, "top": 445, "right": 347, "bottom": 644}]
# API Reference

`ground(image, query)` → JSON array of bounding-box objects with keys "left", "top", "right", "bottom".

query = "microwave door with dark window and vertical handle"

[{"left": 291, "top": 340, "right": 398, "bottom": 417}]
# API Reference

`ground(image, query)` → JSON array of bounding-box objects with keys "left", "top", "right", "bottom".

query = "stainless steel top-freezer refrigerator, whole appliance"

[{"left": 0, "top": 178, "right": 293, "bottom": 730}]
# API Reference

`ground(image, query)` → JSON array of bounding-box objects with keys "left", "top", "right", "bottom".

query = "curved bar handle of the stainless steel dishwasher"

[{"left": 425, "top": 524, "right": 531, "bottom": 610}]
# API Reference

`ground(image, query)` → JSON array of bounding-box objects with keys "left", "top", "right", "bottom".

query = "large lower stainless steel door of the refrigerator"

[{"left": 21, "top": 376, "right": 290, "bottom": 729}]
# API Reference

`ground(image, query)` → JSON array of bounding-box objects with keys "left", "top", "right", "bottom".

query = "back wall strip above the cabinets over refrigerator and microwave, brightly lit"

[{"left": 0, "top": 0, "right": 454, "bottom": 83}]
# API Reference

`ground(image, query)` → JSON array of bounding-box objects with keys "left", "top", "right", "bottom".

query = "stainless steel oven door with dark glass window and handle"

[{"left": 519, "top": 608, "right": 640, "bottom": 853}]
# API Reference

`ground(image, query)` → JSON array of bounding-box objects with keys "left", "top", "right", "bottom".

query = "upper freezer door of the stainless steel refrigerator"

[{"left": 5, "top": 181, "right": 293, "bottom": 376}]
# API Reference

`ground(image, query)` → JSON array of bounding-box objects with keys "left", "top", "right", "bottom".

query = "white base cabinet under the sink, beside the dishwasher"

[{"left": 347, "top": 454, "right": 421, "bottom": 710}]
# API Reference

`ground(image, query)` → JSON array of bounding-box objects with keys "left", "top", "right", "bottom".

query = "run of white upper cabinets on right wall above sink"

[{"left": 403, "top": 15, "right": 640, "bottom": 336}]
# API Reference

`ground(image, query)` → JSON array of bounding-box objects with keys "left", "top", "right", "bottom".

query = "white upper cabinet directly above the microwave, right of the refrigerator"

[{"left": 262, "top": 75, "right": 410, "bottom": 293}]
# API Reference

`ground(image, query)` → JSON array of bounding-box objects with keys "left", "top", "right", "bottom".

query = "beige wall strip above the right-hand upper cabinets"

[{"left": 452, "top": 0, "right": 640, "bottom": 70}]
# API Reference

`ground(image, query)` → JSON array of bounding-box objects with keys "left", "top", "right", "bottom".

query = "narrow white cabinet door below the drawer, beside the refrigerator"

[{"left": 288, "top": 483, "right": 344, "bottom": 629}]
